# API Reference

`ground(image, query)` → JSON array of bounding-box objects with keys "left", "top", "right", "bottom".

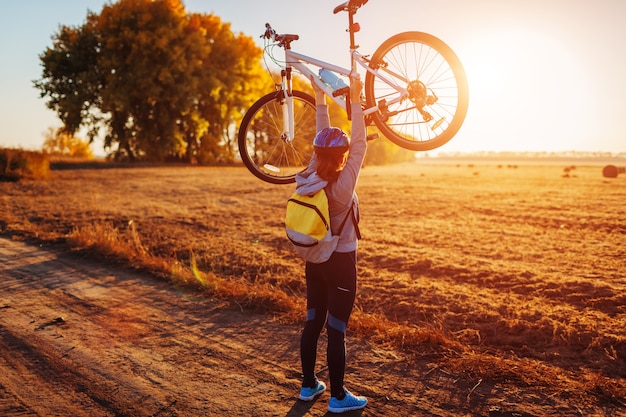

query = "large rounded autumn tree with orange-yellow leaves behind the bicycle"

[{"left": 35, "top": 0, "right": 263, "bottom": 162}]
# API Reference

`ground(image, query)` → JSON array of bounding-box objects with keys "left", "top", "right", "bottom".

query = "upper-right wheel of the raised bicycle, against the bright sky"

[{"left": 365, "top": 32, "right": 469, "bottom": 151}]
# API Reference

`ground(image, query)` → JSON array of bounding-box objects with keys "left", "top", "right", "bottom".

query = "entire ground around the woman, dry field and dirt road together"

[{"left": 0, "top": 164, "right": 626, "bottom": 417}]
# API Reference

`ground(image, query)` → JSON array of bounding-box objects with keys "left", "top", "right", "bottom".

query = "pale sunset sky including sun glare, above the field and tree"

[{"left": 0, "top": 0, "right": 626, "bottom": 153}]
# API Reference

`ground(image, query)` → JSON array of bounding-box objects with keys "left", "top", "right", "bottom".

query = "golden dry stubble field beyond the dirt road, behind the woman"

[{"left": 0, "top": 163, "right": 626, "bottom": 415}]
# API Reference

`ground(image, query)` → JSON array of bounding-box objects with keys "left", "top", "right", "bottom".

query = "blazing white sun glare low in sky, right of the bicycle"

[{"left": 454, "top": 27, "right": 592, "bottom": 151}]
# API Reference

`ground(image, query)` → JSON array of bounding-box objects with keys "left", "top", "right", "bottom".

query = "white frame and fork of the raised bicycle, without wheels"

[{"left": 281, "top": 44, "right": 408, "bottom": 142}]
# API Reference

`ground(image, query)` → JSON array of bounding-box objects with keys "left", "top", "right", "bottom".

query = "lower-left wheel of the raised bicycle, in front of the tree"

[{"left": 238, "top": 90, "right": 315, "bottom": 184}]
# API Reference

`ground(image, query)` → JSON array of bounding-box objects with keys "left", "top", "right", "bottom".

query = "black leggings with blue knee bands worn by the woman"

[{"left": 300, "top": 252, "right": 356, "bottom": 397}]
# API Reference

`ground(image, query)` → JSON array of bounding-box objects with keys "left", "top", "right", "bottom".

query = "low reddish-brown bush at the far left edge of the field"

[{"left": 0, "top": 149, "right": 50, "bottom": 181}]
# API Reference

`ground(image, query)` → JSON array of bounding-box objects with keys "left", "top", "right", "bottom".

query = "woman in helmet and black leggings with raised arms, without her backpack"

[{"left": 296, "top": 79, "right": 367, "bottom": 413}]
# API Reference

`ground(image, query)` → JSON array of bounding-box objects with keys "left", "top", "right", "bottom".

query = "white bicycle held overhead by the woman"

[{"left": 238, "top": 0, "right": 469, "bottom": 184}]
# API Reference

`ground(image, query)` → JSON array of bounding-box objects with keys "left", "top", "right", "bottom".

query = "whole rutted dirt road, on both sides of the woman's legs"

[{"left": 0, "top": 234, "right": 616, "bottom": 417}]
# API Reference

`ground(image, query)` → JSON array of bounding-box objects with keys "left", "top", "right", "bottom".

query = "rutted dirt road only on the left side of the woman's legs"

[{"left": 0, "top": 239, "right": 348, "bottom": 416}]
